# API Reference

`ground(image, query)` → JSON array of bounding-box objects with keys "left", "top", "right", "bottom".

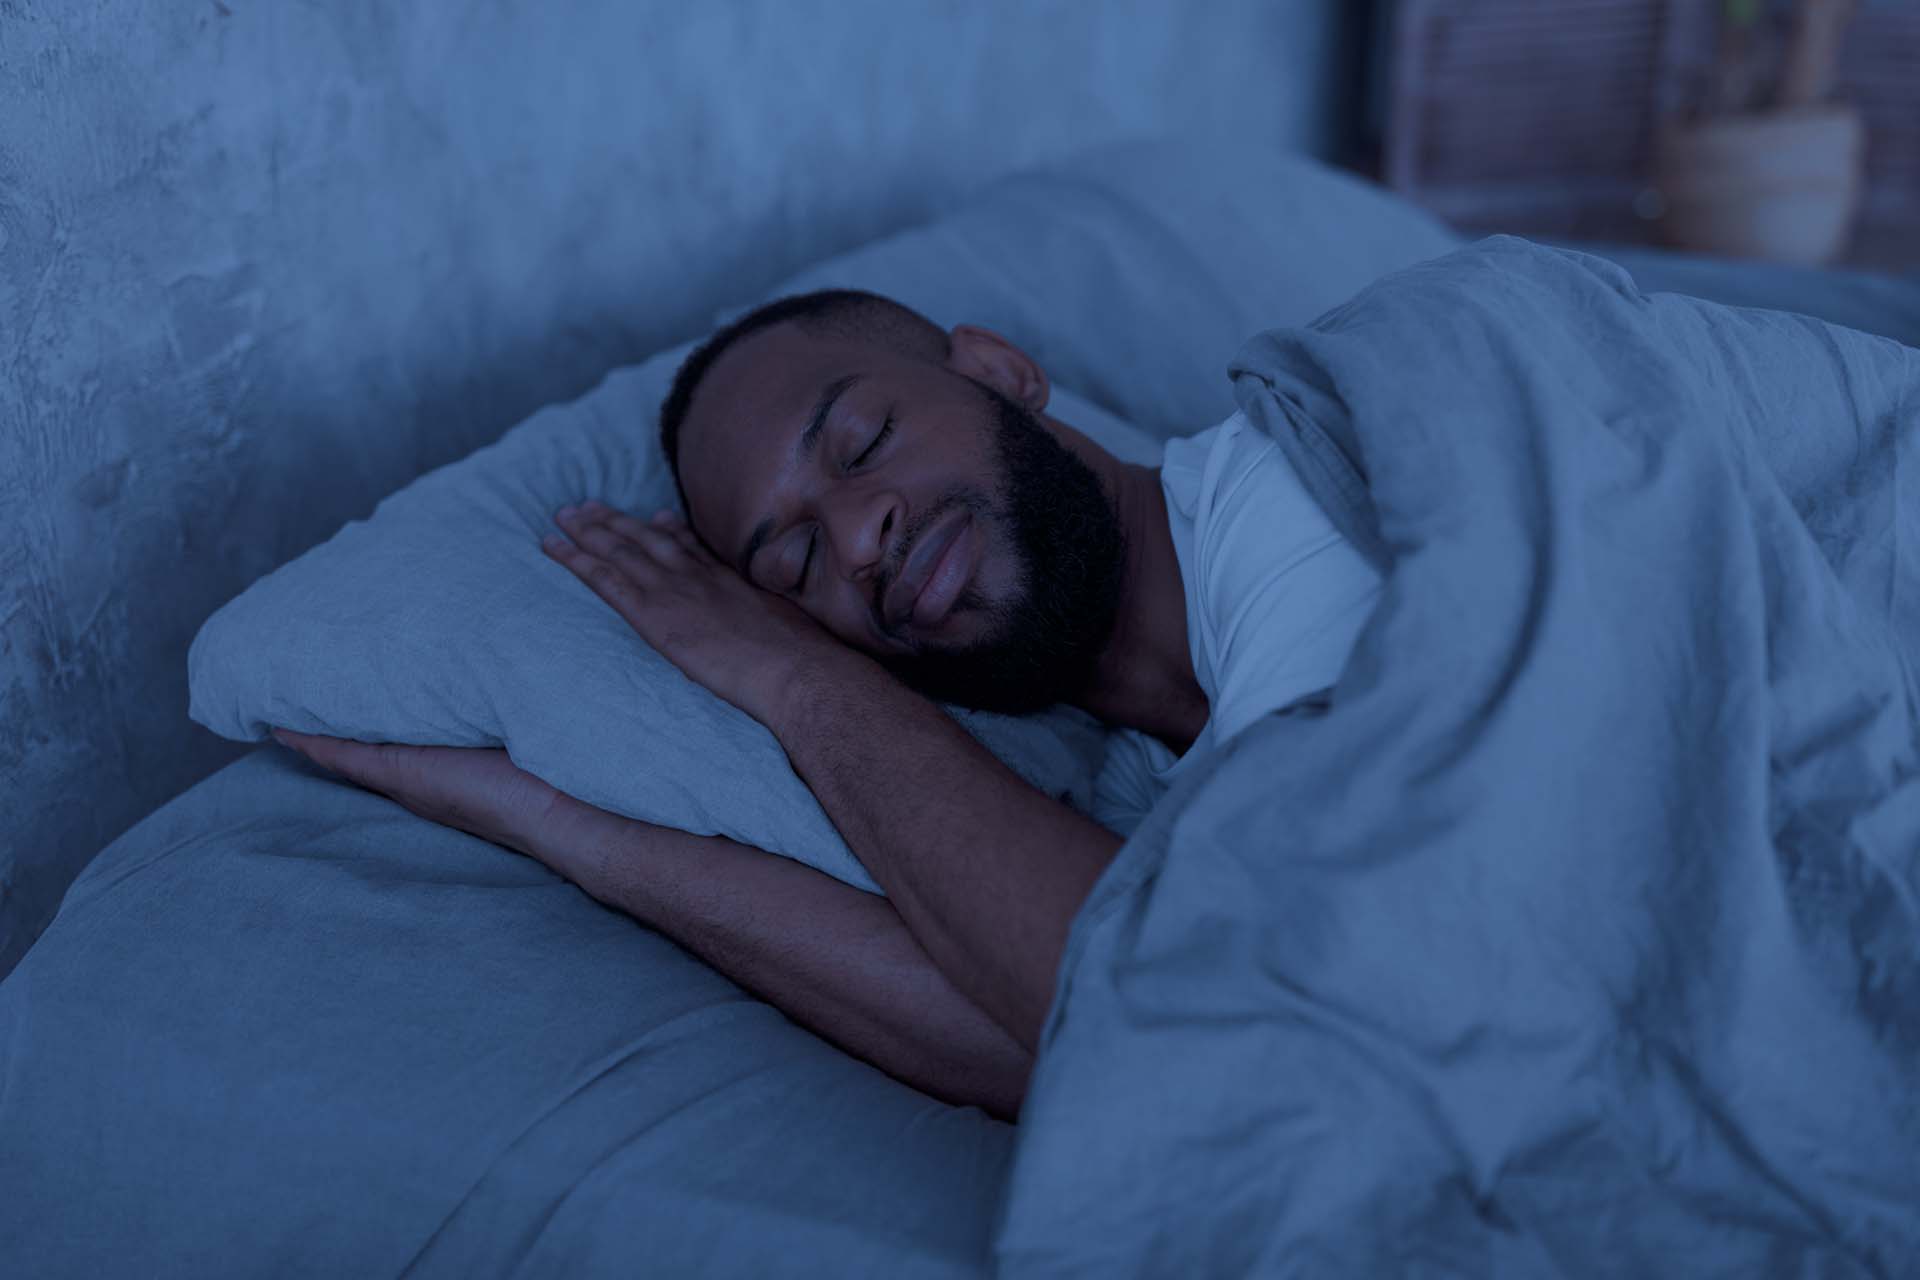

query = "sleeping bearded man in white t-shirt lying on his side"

[{"left": 280, "top": 292, "right": 1379, "bottom": 1115}]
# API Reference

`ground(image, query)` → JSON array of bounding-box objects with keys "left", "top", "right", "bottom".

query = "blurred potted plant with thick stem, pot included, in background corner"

[{"left": 1653, "top": 0, "right": 1864, "bottom": 265}]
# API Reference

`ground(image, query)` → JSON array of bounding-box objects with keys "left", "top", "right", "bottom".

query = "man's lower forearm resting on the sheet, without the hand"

[{"left": 528, "top": 802, "right": 1033, "bottom": 1119}]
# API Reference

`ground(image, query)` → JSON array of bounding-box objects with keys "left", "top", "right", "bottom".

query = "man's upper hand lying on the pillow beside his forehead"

[{"left": 541, "top": 501, "right": 843, "bottom": 723}]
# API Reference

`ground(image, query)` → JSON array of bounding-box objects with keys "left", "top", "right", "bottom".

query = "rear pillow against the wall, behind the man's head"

[{"left": 741, "top": 138, "right": 1465, "bottom": 439}]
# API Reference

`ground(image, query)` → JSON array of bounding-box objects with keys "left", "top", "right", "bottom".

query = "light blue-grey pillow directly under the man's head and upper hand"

[{"left": 188, "top": 344, "right": 1160, "bottom": 892}]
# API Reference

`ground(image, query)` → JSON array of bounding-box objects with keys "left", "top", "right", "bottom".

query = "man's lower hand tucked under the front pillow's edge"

[{"left": 271, "top": 729, "right": 601, "bottom": 879}]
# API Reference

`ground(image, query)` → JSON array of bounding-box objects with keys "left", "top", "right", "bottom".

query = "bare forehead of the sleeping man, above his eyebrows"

[{"left": 680, "top": 324, "right": 856, "bottom": 557}]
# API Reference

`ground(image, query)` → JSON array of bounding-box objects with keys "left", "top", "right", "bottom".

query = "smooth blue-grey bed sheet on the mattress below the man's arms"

[{"left": 0, "top": 747, "right": 1010, "bottom": 1278}]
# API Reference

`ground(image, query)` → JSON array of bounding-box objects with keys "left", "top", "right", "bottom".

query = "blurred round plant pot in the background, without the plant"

[{"left": 1653, "top": 106, "right": 1864, "bottom": 267}]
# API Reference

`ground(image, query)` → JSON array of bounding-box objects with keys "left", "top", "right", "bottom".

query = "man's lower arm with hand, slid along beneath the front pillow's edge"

[{"left": 273, "top": 727, "right": 1033, "bottom": 1119}]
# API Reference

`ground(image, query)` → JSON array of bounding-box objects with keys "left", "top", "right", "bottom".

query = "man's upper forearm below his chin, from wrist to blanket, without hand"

[{"left": 768, "top": 649, "right": 1121, "bottom": 1052}]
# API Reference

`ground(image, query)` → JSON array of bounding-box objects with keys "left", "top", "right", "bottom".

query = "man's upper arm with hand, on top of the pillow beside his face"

[{"left": 543, "top": 503, "right": 1121, "bottom": 1052}]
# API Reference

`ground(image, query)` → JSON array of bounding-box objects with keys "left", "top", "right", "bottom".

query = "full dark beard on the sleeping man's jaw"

[{"left": 883, "top": 386, "right": 1127, "bottom": 716}]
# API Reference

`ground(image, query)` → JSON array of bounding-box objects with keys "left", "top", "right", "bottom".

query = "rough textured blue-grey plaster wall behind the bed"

[{"left": 0, "top": 0, "right": 1340, "bottom": 973}]
